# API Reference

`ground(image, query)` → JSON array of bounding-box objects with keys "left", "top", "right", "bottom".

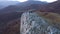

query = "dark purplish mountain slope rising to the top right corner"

[{"left": 44, "top": 1, "right": 60, "bottom": 14}]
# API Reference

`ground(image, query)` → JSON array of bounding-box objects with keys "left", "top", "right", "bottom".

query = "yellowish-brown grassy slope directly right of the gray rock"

[{"left": 37, "top": 12, "right": 60, "bottom": 28}]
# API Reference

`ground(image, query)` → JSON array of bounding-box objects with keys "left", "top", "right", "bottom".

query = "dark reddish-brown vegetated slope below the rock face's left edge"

[{"left": 2, "top": 19, "right": 20, "bottom": 34}]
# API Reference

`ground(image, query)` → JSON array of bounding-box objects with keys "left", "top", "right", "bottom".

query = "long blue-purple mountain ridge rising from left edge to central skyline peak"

[{"left": 0, "top": 1, "right": 48, "bottom": 14}]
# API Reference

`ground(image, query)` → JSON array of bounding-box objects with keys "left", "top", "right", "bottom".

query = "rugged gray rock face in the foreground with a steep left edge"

[{"left": 20, "top": 12, "right": 60, "bottom": 34}]
